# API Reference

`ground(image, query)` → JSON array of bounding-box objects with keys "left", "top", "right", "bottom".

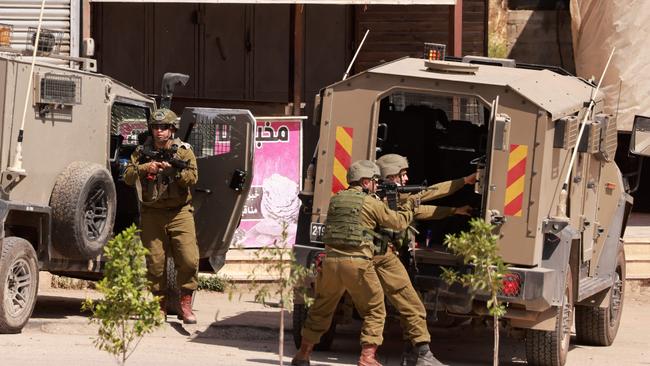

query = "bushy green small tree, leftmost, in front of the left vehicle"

[{"left": 82, "top": 225, "right": 163, "bottom": 365}]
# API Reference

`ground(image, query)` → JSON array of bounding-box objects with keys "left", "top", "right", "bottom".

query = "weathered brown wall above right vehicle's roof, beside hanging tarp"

[{"left": 507, "top": 10, "right": 575, "bottom": 73}]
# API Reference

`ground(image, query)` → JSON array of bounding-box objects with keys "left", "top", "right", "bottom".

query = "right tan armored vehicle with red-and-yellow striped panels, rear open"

[{"left": 294, "top": 57, "right": 648, "bottom": 365}]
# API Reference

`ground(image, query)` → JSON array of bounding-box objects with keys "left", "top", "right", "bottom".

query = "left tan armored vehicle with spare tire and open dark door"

[{"left": 0, "top": 44, "right": 254, "bottom": 333}]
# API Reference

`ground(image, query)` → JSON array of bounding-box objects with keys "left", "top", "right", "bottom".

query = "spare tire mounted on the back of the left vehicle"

[{"left": 50, "top": 161, "right": 117, "bottom": 259}]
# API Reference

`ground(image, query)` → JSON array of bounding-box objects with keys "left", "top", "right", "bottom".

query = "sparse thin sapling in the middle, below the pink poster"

[{"left": 248, "top": 223, "right": 313, "bottom": 366}]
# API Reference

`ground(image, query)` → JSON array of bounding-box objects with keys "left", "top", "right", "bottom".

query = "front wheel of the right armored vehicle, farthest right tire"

[{"left": 576, "top": 250, "right": 625, "bottom": 346}]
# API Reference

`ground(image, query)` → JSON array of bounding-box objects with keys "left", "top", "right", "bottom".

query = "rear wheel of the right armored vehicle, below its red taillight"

[{"left": 526, "top": 269, "right": 573, "bottom": 366}]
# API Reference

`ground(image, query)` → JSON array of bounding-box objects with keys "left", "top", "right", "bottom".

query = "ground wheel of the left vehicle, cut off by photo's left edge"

[{"left": 0, "top": 237, "right": 38, "bottom": 333}]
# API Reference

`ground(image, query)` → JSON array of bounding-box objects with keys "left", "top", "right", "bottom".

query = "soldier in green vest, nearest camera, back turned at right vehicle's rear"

[{"left": 291, "top": 160, "right": 413, "bottom": 366}]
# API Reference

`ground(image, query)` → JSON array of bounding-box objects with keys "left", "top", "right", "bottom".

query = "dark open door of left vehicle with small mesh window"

[{"left": 179, "top": 108, "right": 255, "bottom": 270}]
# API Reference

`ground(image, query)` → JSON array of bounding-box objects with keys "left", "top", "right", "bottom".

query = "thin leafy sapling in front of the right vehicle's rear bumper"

[{"left": 442, "top": 219, "right": 507, "bottom": 366}]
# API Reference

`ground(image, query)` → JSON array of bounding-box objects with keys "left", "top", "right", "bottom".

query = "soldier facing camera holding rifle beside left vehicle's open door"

[{"left": 124, "top": 109, "right": 199, "bottom": 324}]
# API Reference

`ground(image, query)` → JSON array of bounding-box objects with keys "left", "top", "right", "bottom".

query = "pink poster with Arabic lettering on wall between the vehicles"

[{"left": 233, "top": 117, "right": 307, "bottom": 248}]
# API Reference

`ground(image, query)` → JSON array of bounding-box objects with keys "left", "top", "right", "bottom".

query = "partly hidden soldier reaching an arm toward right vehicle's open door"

[{"left": 373, "top": 154, "right": 476, "bottom": 366}]
